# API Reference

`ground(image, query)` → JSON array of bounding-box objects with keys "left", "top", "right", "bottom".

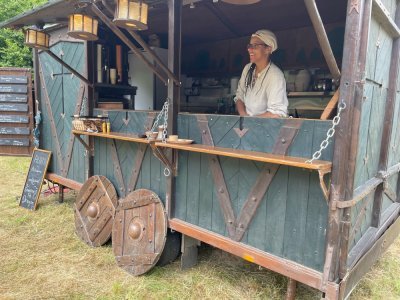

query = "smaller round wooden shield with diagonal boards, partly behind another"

[{"left": 74, "top": 175, "right": 118, "bottom": 247}]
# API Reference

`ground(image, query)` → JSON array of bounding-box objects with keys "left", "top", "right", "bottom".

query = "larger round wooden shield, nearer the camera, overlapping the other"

[{"left": 112, "top": 189, "right": 167, "bottom": 276}]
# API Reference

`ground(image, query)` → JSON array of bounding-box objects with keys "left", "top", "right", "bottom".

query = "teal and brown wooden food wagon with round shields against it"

[{"left": 0, "top": 0, "right": 400, "bottom": 299}]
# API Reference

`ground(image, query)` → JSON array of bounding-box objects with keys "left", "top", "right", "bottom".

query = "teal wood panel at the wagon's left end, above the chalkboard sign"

[{"left": 40, "top": 42, "right": 86, "bottom": 182}]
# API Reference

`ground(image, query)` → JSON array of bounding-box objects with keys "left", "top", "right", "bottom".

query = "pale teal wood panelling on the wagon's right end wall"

[{"left": 350, "top": 10, "right": 398, "bottom": 249}]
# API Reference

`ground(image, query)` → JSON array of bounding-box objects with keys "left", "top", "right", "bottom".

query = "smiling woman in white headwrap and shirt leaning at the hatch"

[{"left": 234, "top": 30, "right": 288, "bottom": 118}]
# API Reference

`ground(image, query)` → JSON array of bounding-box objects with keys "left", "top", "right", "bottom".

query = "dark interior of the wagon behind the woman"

[{"left": 90, "top": 0, "right": 347, "bottom": 119}]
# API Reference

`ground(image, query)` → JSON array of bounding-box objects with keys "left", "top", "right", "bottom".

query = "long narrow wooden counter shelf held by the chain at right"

[{"left": 155, "top": 142, "right": 332, "bottom": 172}]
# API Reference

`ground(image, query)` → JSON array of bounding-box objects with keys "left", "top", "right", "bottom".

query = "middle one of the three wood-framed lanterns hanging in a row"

[{"left": 68, "top": 14, "right": 99, "bottom": 41}]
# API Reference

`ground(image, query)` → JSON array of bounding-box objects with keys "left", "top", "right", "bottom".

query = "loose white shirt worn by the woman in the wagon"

[{"left": 235, "top": 63, "right": 289, "bottom": 117}]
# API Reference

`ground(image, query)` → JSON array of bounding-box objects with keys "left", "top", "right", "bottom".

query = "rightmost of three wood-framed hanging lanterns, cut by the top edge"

[{"left": 114, "top": 0, "right": 149, "bottom": 30}]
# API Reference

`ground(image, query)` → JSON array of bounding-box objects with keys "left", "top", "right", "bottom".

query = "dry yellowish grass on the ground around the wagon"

[{"left": 0, "top": 157, "right": 400, "bottom": 300}]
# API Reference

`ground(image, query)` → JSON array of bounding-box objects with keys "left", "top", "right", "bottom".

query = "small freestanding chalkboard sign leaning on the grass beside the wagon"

[{"left": 19, "top": 149, "right": 51, "bottom": 210}]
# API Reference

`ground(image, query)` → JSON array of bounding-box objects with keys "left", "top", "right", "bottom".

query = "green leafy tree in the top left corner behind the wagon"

[{"left": 0, "top": 0, "right": 47, "bottom": 67}]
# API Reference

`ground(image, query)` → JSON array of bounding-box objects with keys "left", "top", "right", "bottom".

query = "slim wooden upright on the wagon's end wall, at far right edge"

[{"left": 371, "top": 5, "right": 400, "bottom": 227}]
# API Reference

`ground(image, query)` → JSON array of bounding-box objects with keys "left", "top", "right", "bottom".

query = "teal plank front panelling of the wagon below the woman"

[{"left": 174, "top": 114, "right": 333, "bottom": 271}]
